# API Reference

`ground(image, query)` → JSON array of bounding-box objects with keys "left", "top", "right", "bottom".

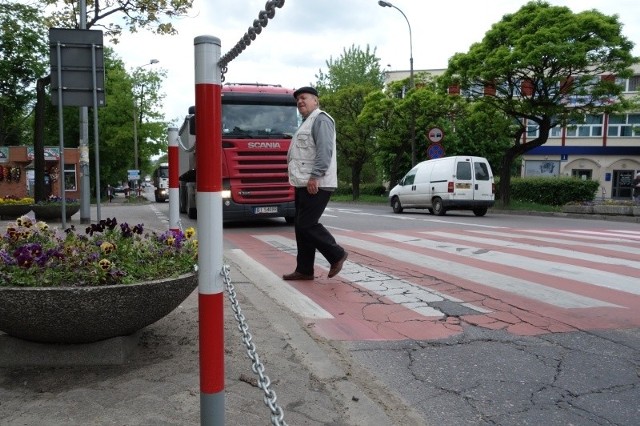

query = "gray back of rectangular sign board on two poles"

[{"left": 49, "top": 28, "right": 106, "bottom": 107}]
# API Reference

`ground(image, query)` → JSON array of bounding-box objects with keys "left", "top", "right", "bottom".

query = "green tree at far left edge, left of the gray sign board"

[{"left": 0, "top": 3, "right": 47, "bottom": 146}]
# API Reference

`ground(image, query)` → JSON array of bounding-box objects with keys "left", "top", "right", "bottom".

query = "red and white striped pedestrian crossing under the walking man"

[{"left": 226, "top": 227, "right": 640, "bottom": 340}]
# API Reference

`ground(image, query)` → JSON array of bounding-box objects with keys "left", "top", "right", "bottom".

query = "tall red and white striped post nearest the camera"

[{"left": 194, "top": 35, "right": 224, "bottom": 425}]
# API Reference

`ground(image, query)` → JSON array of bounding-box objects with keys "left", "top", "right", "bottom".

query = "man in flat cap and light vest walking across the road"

[{"left": 282, "top": 87, "right": 348, "bottom": 280}]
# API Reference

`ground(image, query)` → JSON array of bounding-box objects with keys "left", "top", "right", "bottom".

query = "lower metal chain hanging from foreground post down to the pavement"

[{"left": 222, "top": 265, "right": 287, "bottom": 426}]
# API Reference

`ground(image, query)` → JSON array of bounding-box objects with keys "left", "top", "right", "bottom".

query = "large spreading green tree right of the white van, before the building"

[{"left": 445, "top": 1, "right": 636, "bottom": 205}]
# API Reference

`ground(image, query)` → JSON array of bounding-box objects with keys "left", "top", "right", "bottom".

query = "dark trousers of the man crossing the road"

[{"left": 294, "top": 187, "right": 344, "bottom": 275}]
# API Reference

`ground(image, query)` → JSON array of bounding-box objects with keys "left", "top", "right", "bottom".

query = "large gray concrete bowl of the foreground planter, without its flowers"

[{"left": 0, "top": 274, "right": 198, "bottom": 343}]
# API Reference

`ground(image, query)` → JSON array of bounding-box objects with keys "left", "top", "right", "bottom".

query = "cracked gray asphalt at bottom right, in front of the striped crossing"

[{"left": 347, "top": 326, "right": 640, "bottom": 426}]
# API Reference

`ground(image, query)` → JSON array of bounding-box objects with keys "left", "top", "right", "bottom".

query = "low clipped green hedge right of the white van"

[{"left": 511, "top": 177, "right": 599, "bottom": 206}]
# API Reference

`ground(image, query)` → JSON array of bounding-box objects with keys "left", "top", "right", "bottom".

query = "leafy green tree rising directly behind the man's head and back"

[{"left": 316, "top": 46, "right": 383, "bottom": 200}]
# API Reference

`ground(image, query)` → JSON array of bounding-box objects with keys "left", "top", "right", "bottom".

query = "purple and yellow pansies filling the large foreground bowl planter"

[{"left": 0, "top": 216, "right": 198, "bottom": 287}]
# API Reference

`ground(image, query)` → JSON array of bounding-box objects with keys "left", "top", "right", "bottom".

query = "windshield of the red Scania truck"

[{"left": 222, "top": 104, "right": 299, "bottom": 138}]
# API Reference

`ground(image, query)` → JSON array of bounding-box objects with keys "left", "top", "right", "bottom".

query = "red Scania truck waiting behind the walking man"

[{"left": 179, "top": 83, "right": 301, "bottom": 223}]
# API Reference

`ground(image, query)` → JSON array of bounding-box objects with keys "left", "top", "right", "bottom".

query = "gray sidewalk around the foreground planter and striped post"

[{"left": 0, "top": 203, "right": 410, "bottom": 426}]
